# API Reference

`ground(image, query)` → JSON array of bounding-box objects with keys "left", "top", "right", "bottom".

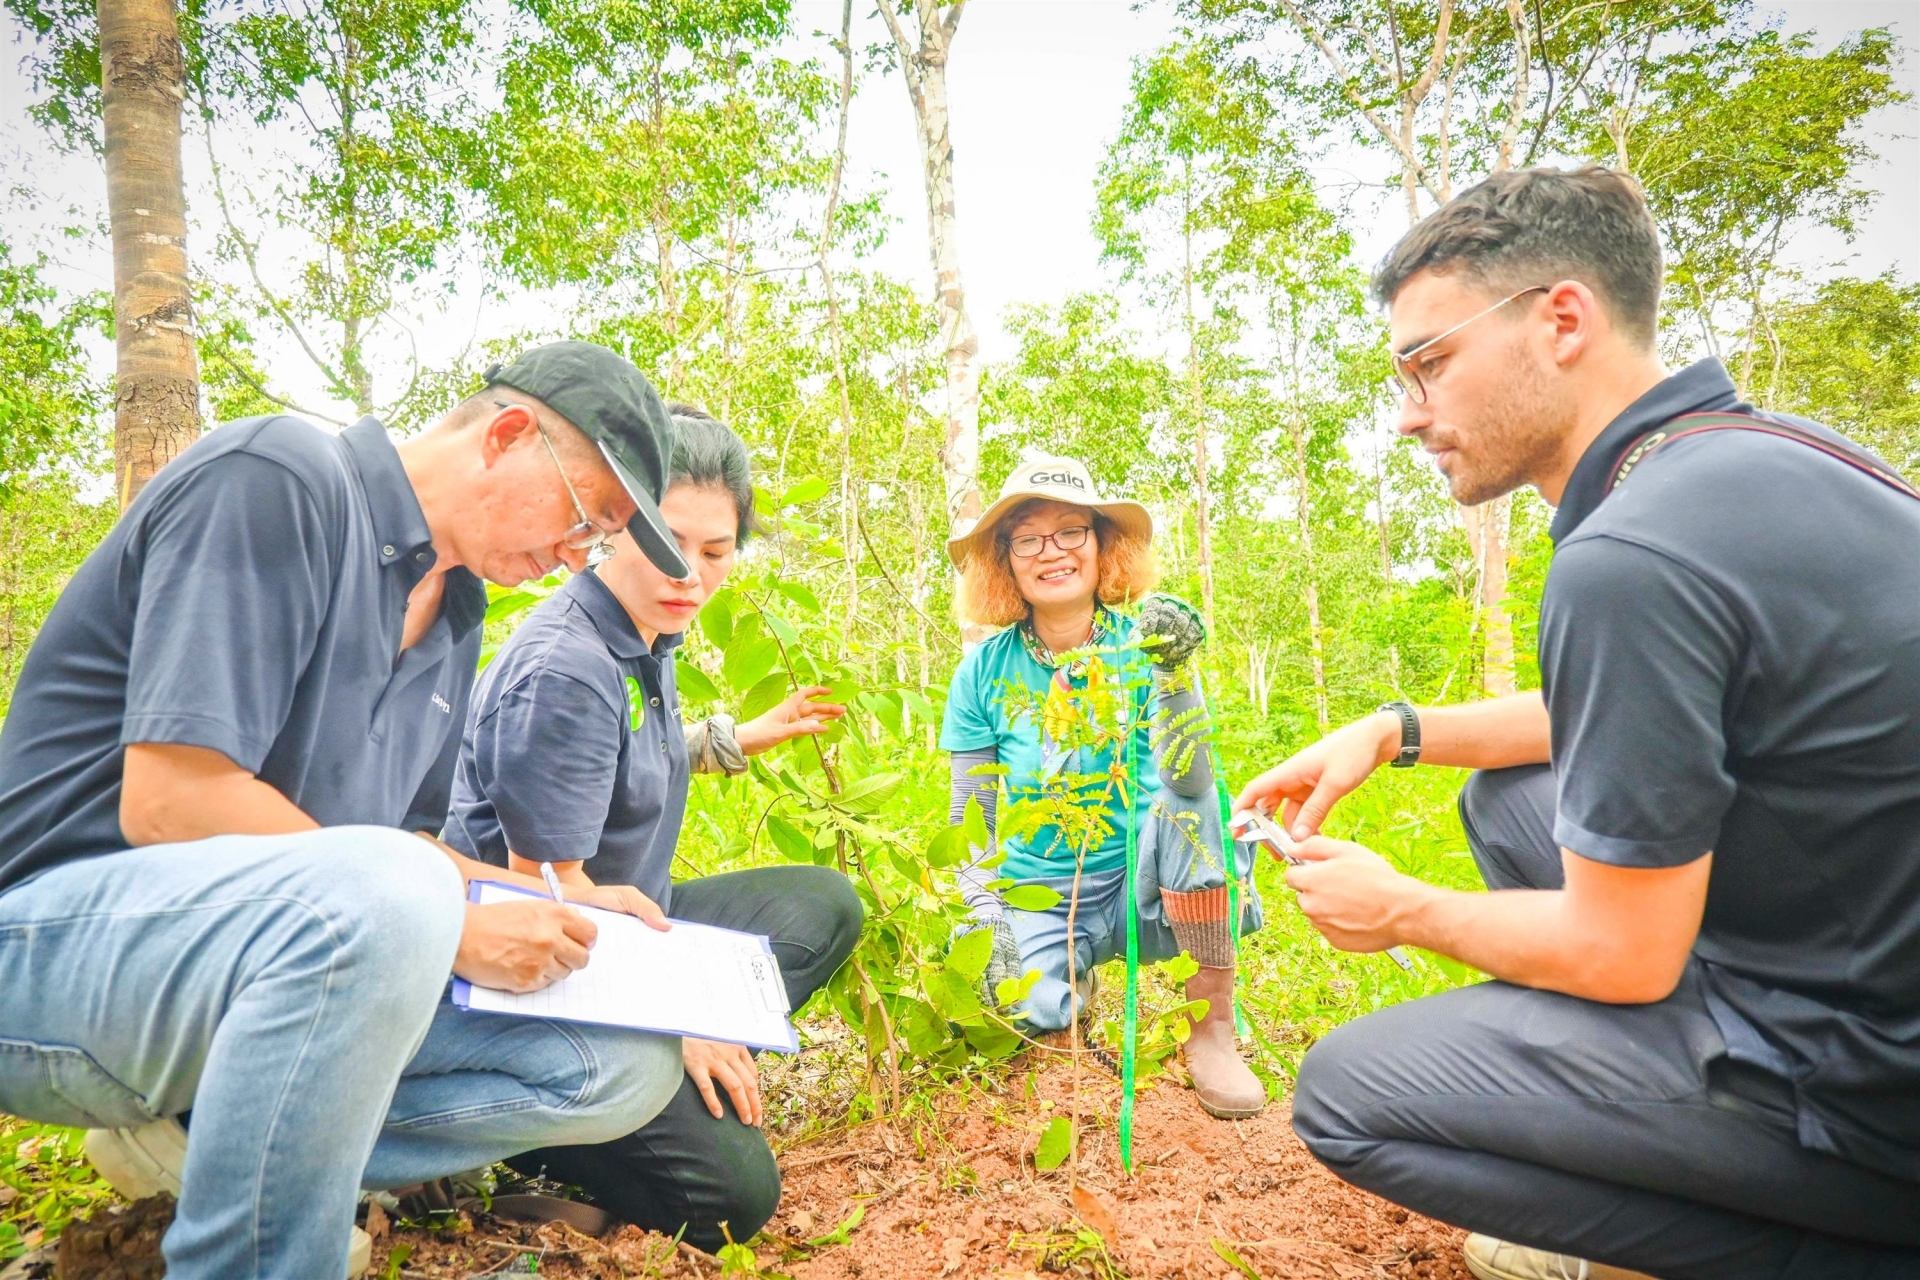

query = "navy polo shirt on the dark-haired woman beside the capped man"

[{"left": 444, "top": 574, "right": 687, "bottom": 910}]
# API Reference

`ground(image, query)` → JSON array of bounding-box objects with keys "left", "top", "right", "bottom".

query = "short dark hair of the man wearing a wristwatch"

[{"left": 1373, "top": 165, "right": 1661, "bottom": 345}]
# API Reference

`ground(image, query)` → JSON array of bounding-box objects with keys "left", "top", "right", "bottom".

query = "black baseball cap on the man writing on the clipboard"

[{"left": 486, "top": 342, "right": 691, "bottom": 578}]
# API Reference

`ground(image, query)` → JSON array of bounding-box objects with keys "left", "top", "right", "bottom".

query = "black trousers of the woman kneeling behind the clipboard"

[{"left": 507, "top": 867, "right": 864, "bottom": 1253}]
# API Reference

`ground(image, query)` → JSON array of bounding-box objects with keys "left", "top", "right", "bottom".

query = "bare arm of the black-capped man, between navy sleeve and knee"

[{"left": 119, "top": 743, "right": 321, "bottom": 848}]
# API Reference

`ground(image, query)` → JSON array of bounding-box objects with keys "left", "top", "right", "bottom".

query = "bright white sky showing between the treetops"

[{"left": 0, "top": 0, "right": 1920, "bottom": 416}]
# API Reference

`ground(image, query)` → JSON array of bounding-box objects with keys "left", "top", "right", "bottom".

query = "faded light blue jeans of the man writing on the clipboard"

[{"left": 0, "top": 827, "right": 682, "bottom": 1280}]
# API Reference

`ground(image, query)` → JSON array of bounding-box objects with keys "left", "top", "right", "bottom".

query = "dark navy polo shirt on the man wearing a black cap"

[{"left": 0, "top": 416, "right": 486, "bottom": 890}]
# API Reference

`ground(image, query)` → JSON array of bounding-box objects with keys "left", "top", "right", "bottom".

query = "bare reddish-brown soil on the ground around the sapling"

[{"left": 374, "top": 1067, "right": 1471, "bottom": 1280}]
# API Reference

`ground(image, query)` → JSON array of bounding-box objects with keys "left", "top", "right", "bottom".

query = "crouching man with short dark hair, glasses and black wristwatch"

[{"left": 1240, "top": 171, "right": 1920, "bottom": 1280}]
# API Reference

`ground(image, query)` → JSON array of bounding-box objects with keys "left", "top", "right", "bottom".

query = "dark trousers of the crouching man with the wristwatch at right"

[{"left": 1294, "top": 766, "right": 1920, "bottom": 1280}]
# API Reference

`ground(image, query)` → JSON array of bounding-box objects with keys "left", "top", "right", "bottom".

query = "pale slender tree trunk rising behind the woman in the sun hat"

[{"left": 879, "top": 0, "right": 985, "bottom": 641}]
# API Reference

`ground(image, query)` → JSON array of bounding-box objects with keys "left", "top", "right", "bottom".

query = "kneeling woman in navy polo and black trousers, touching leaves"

[{"left": 445, "top": 405, "right": 862, "bottom": 1253}]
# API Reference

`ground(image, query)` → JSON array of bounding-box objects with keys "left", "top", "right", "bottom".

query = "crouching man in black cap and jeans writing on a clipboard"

[{"left": 0, "top": 342, "right": 687, "bottom": 1280}]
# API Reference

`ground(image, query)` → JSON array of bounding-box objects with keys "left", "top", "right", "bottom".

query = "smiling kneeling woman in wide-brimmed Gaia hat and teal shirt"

[{"left": 941, "top": 459, "right": 1267, "bottom": 1119}]
